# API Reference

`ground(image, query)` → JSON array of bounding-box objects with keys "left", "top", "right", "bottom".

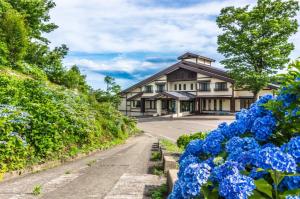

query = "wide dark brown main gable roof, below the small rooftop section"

[{"left": 121, "top": 61, "right": 234, "bottom": 94}]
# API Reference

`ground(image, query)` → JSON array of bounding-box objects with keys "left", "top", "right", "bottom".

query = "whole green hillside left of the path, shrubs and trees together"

[{"left": 0, "top": 0, "right": 136, "bottom": 174}]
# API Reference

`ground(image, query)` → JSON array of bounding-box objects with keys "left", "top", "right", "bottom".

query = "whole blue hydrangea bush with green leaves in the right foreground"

[{"left": 169, "top": 62, "right": 300, "bottom": 199}]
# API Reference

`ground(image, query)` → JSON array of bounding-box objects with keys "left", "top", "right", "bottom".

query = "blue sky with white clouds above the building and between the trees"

[{"left": 47, "top": 0, "right": 300, "bottom": 89}]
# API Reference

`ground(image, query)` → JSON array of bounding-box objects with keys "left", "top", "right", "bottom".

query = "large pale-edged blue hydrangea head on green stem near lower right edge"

[{"left": 255, "top": 147, "right": 297, "bottom": 173}]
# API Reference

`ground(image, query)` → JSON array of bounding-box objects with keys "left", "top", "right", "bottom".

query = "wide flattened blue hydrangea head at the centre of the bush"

[{"left": 226, "top": 137, "right": 259, "bottom": 153}]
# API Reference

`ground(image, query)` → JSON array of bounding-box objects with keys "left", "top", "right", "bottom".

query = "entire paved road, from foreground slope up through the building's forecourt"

[{"left": 0, "top": 116, "right": 232, "bottom": 199}]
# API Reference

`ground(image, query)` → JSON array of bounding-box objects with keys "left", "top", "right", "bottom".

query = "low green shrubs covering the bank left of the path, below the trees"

[{"left": 0, "top": 70, "right": 135, "bottom": 171}]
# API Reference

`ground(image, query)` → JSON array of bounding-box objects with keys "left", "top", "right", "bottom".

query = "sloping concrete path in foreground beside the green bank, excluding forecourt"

[{"left": 0, "top": 135, "right": 157, "bottom": 199}]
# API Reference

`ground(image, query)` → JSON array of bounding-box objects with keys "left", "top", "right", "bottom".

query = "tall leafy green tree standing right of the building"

[{"left": 217, "top": 0, "right": 299, "bottom": 98}]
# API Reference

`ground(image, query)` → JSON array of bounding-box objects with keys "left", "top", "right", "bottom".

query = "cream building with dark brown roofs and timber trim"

[{"left": 119, "top": 53, "right": 278, "bottom": 117}]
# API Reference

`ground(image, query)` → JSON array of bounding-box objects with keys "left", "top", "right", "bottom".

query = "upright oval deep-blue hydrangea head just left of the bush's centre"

[{"left": 202, "top": 130, "right": 225, "bottom": 155}]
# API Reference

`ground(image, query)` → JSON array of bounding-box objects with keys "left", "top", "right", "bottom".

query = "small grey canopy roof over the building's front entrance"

[{"left": 151, "top": 91, "right": 196, "bottom": 101}]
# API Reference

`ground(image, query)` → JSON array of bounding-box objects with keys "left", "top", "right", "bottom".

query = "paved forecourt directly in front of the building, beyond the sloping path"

[{"left": 138, "top": 116, "right": 234, "bottom": 142}]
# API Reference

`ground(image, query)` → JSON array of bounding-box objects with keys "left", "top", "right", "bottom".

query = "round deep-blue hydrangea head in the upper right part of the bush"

[{"left": 251, "top": 115, "right": 276, "bottom": 141}]
